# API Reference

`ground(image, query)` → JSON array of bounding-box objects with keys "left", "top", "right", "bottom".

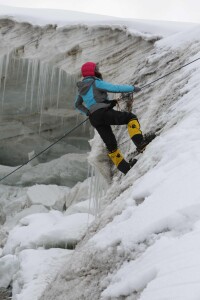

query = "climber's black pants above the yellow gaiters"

[{"left": 90, "top": 108, "right": 137, "bottom": 152}]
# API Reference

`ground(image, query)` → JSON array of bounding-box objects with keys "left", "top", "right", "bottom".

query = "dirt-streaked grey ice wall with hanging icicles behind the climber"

[{"left": 0, "top": 19, "right": 157, "bottom": 176}]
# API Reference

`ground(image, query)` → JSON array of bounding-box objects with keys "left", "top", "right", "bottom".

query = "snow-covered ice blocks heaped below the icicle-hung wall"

[{"left": 0, "top": 180, "right": 94, "bottom": 300}]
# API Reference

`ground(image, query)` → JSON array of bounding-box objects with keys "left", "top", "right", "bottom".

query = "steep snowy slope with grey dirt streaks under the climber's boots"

[{"left": 41, "top": 27, "right": 200, "bottom": 300}]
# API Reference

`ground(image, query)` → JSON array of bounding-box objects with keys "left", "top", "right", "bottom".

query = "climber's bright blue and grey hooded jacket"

[{"left": 75, "top": 77, "right": 134, "bottom": 114}]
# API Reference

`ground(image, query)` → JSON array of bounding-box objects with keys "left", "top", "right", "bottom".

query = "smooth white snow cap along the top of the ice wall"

[{"left": 0, "top": 5, "right": 195, "bottom": 38}]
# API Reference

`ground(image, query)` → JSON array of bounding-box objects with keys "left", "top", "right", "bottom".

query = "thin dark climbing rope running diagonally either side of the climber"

[{"left": 0, "top": 57, "right": 200, "bottom": 182}]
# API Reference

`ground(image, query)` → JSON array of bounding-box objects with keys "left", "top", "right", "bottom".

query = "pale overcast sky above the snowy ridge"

[{"left": 0, "top": 0, "right": 200, "bottom": 23}]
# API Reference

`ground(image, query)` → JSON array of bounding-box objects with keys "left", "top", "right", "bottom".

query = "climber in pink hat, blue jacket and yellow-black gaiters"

[{"left": 75, "top": 62, "right": 149, "bottom": 174}]
